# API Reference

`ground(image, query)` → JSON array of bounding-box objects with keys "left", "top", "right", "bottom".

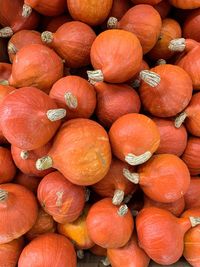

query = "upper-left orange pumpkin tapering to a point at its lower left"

[{"left": 8, "top": 44, "right": 63, "bottom": 92}]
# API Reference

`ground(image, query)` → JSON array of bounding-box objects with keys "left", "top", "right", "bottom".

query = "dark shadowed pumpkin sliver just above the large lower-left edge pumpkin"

[{"left": 13, "top": 172, "right": 41, "bottom": 194}]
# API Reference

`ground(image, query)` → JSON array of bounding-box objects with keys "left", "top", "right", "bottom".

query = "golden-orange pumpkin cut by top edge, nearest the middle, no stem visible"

[{"left": 67, "top": 0, "right": 113, "bottom": 26}]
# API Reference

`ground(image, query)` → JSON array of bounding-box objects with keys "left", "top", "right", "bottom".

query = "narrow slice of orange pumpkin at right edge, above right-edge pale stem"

[{"left": 184, "top": 179, "right": 200, "bottom": 210}]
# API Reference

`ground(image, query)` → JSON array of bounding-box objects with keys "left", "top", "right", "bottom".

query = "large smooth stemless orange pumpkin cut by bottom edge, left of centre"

[{"left": 18, "top": 233, "right": 77, "bottom": 267}]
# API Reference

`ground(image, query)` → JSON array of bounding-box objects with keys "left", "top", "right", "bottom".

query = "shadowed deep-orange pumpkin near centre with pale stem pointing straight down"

[{"left": 92, "top": 158, "right": 136, "bottom": 205}]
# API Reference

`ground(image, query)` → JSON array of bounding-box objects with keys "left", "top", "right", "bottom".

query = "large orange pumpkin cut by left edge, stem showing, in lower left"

[{"left": 0, "top": 183, "right": 38, "bottom": 244}]
